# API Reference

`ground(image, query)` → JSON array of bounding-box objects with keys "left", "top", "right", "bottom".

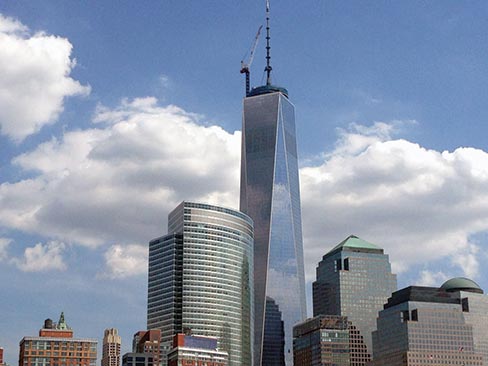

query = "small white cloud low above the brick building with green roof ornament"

[{"left": 11, "top": 241, "right": 66, "bottom": 272}]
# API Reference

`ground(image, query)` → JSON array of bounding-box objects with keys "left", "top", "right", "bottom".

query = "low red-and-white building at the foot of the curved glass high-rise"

[{"left": 168, "top": 334, "right": 229, "bottom": 366}]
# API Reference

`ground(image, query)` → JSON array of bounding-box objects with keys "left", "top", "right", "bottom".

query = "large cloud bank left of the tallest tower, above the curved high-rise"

[{"left": 0, "top": 98, "right": 241, "bottom": 246}]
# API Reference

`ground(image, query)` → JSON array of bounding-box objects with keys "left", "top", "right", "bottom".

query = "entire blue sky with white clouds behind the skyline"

[{"left": 0, "top": 0, "right": 488, "bottom": 365}]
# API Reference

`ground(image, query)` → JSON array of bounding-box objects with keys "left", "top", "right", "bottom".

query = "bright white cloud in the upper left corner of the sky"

[{"left": 0, "top": 14, "right": 90, "bottom": 142}]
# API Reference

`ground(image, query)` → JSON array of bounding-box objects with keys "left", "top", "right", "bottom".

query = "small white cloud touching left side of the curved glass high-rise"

[{"left": 101, "top": 244, "right": 148, "bottom": 278}]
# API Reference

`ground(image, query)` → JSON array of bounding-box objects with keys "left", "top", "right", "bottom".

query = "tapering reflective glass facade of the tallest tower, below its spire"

[{"left": 240, "top": 92, "right": 306, "bottom": 366}]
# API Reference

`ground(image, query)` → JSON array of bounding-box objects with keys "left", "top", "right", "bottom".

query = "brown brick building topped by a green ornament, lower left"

[{"left": 19, "top": 313, "right": 97, "bottom": 366}]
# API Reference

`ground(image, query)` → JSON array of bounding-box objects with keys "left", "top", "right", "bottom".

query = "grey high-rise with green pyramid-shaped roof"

[{"left": 313, "top": 235, "right": 397, "bottom": 366}]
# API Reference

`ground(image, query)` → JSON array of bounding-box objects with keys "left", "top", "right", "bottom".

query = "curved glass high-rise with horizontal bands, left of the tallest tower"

[{"left": 147, "top": 202, "right": 253, "bottom": 366}]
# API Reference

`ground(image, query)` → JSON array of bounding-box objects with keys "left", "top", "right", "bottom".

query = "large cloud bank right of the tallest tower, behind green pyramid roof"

[{"left": 301, "top": 124, "right": 488, "bottom": 277}]
